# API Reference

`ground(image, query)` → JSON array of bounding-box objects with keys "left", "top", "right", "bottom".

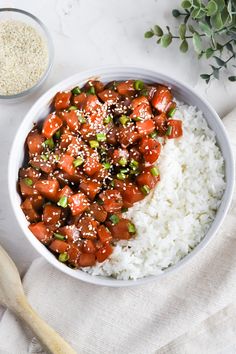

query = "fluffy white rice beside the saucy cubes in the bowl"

[{"left": 86, "top": 104, "right": 225, "bottom": 279}]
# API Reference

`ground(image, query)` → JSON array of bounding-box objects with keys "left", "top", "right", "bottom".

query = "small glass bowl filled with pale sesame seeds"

[{"left": 0, "top": 8, "right": 54, "bottom": 102}]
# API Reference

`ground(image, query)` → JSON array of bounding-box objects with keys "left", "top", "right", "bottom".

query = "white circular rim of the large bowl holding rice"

[{"left": 8, "top": 65, "right": 235, "bottom": 287}]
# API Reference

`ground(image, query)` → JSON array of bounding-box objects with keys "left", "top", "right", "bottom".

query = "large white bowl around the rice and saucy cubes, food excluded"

[{"left": 8, "top": 67, "right": 234, "bottom": 287}]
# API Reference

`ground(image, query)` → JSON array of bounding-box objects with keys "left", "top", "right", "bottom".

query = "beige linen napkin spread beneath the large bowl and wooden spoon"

[{"left": 0, "top": 112, "right": 236, "bottom": 354}]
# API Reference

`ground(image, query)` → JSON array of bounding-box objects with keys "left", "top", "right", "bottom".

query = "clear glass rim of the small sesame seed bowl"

[{"left": 0, "top": 7, "right": 55, "bottom": 102}]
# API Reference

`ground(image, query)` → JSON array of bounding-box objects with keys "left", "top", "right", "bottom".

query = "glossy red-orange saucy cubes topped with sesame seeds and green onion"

[{"left": 19, "top": 80, "right": 183, "bottom": 268}]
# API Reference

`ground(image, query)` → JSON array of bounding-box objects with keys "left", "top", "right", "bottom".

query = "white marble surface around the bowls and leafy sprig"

[{"left": 0, "top": 0, "right": 236, "bottom": 273}]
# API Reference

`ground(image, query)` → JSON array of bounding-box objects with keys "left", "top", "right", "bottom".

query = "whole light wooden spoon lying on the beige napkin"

[{"left": 0, "top": 246, "right": 76, "bottom": 354}]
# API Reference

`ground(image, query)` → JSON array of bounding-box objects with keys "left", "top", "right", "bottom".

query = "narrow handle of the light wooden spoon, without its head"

[{"left": 14, "top": 296, "right": 77, "bottom": 354}]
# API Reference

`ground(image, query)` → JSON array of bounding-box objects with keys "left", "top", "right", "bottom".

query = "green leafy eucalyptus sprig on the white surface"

[{"left": 144, "top": 0, "right": 236, "bottom": 83}]
